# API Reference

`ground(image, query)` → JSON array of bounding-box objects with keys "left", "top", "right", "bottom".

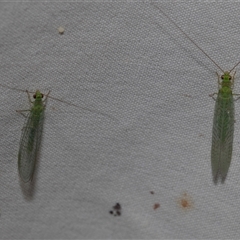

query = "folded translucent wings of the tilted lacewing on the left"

[{"left": 18, "top": 110, "right": 44, "bottom": 182}]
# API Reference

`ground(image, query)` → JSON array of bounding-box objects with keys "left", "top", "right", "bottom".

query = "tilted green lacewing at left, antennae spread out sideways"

[{"left": 0, "top": 84, "right": 112, "bottom": 183}]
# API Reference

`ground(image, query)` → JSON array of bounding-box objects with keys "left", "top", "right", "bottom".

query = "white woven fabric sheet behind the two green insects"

[{"left": 0, "top": 1, "right": 240, "bottom": 239}]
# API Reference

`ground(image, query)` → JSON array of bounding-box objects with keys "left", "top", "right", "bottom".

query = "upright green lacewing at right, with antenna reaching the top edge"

[{"left": 150, "top": 2, "right": 240, "bottom": 183}]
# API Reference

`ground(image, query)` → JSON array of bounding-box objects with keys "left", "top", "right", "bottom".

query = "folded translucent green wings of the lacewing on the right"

[{"left": 211, "top": 94, "right": 234, "bottom": 181}]
